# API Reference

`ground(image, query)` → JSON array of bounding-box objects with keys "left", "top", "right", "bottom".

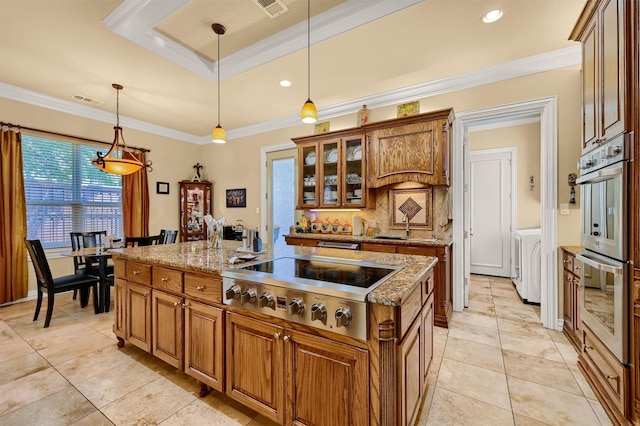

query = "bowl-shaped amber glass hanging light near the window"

[{"left": 91, "top": 83, "right": 144, "bottom": 175}]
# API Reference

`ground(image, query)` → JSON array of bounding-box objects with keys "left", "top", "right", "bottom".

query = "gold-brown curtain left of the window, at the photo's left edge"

[{"left": 0, "top": 128, "right": 29, "bottom": 304}]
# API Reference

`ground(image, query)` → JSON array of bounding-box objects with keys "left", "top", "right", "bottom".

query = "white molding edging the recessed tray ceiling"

[{"left": 103, "top": 0, "right": 425, "bottom": 82}]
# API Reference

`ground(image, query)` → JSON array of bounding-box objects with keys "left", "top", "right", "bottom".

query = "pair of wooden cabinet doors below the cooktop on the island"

[{"left": 227, "top": 313, "right": 369, "bottom": 426}]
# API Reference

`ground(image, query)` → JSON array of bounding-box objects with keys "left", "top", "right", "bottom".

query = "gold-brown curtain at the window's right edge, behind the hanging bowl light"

[{"left": 122, "top": 152, "right": 149, "bottom": 237}]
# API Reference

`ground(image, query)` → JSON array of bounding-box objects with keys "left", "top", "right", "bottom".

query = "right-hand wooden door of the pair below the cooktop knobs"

[{"left": 284, "top": 329, "right": 369, "bottom": 426}]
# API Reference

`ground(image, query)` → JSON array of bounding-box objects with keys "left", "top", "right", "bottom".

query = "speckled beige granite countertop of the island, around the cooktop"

[{"left": 112, "top": 240, "right": 438, "bottom": 306}]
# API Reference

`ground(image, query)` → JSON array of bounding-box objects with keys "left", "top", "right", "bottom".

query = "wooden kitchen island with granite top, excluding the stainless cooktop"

[{"left": 113, "top": 241, "right": 437, "bottom": 425}]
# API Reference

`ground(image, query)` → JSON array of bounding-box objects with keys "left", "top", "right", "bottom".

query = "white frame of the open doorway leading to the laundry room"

[{"left": 451, "top": 96, "right": 561, "bottom": 330}]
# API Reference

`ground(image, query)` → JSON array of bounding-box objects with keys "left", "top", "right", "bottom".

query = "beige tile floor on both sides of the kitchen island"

[{"left": 0, "top": 276, "right": 611, "bottom": 426}]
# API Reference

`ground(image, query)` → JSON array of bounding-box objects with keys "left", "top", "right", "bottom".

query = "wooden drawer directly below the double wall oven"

[{"left": 581, "top": 327, "right": 627, "bottom": 413}]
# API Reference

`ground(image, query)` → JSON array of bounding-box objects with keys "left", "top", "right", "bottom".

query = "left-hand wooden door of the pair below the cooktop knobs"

[{"left": 226, "top": 312, "right": 284, "bottom": 424}]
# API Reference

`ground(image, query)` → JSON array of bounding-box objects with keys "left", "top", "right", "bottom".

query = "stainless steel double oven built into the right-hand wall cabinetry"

[{"left": 576, "top": 134, "right": 630, "bottom": 363}]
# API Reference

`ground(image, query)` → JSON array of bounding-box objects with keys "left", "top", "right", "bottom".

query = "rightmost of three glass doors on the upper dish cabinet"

[{"left": 342, "top": 136, "right": 366, "bottom": 207}]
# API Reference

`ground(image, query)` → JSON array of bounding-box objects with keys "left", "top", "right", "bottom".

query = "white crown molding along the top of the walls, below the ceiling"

[{"left": 0, "top": 46, "right": 581, "bottom": 145}]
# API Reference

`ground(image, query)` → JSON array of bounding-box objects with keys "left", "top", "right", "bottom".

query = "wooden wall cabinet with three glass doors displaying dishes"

[{"left": 293, "top": 131, "right": 374, "bottom": 209}]
